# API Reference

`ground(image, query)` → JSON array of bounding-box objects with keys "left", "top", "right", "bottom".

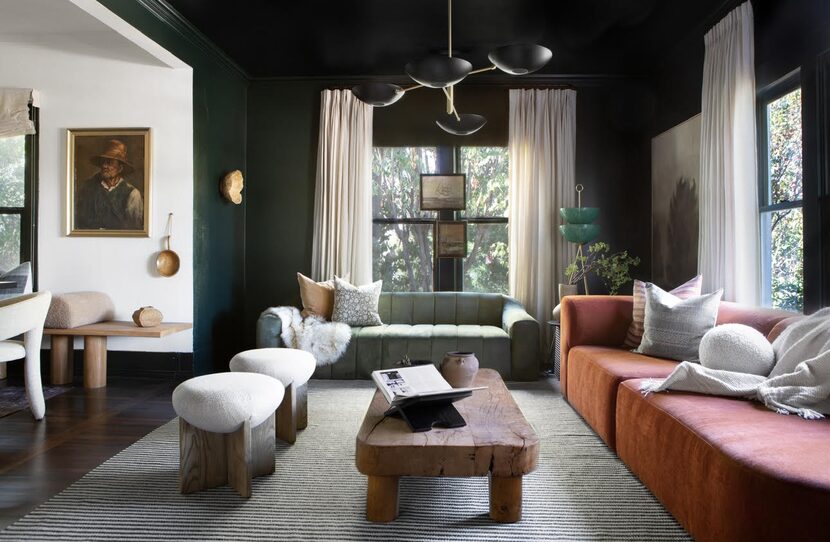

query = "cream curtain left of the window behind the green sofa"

[{"left": 311, "top": 90, "right": 372, "bottom": 284}]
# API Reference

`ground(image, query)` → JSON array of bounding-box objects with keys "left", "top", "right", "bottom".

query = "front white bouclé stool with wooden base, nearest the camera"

[{"left": 173, "top": 373, "right": 285, "bottom": 497}]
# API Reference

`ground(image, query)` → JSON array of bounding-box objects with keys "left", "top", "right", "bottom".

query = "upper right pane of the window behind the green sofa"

[{"left": 459, "top": 147, "right": 507, "bottom": 217}]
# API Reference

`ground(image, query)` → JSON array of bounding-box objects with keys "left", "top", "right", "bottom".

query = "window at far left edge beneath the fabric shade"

[{"left": 0, "top": 109, "right": 37, "bottom": 287}]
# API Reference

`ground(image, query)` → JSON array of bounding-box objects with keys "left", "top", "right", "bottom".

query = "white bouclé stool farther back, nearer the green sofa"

[{"left": 230, "top": 348, "right": 317, "bottom": 444}]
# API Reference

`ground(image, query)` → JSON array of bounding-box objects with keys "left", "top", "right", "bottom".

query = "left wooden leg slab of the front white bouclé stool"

[{"left": 179, "top": 418, "right": 228, "bottom": 493}]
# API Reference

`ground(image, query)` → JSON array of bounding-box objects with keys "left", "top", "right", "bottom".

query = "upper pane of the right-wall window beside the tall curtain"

[{"left": 767, "top": 89, "right": 802, "bottom": 204}]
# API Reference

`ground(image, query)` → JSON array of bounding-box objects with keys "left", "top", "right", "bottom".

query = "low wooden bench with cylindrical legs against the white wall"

[{"left": 43, "top": 322, "right": 193, "bottom": 388}]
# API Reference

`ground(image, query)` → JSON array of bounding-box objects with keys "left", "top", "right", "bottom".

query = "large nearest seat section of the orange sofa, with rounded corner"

[{"left": 616, "top": 380, "right": 830, "bottom": 541}]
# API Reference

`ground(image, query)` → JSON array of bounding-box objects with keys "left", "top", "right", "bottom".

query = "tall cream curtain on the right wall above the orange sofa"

[{"left": 698, "top": 2, "right": 761, "bottom": 305}]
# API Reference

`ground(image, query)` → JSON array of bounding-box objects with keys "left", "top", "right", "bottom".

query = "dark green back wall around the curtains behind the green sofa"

[{"left": 245, "top": 76, "right": 651, "bottom": 347}]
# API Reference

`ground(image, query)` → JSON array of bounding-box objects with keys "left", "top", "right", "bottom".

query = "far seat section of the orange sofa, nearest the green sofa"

[{"left": 568, "top": 346, "right": 677, "bottom": 449}]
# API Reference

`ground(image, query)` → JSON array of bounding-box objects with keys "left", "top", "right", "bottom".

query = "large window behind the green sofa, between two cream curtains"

[{"left": 372, "top": 147, "right": 508, "bottom": 293}]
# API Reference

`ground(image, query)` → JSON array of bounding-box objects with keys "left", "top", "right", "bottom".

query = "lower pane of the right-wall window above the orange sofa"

[{"left": 761, "top": 207, "right": 804, "bottom": 312}]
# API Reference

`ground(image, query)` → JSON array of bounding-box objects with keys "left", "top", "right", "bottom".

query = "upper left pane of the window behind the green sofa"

[{"left": 372, "top": 147, "right": 438, "bottom": 218}]
